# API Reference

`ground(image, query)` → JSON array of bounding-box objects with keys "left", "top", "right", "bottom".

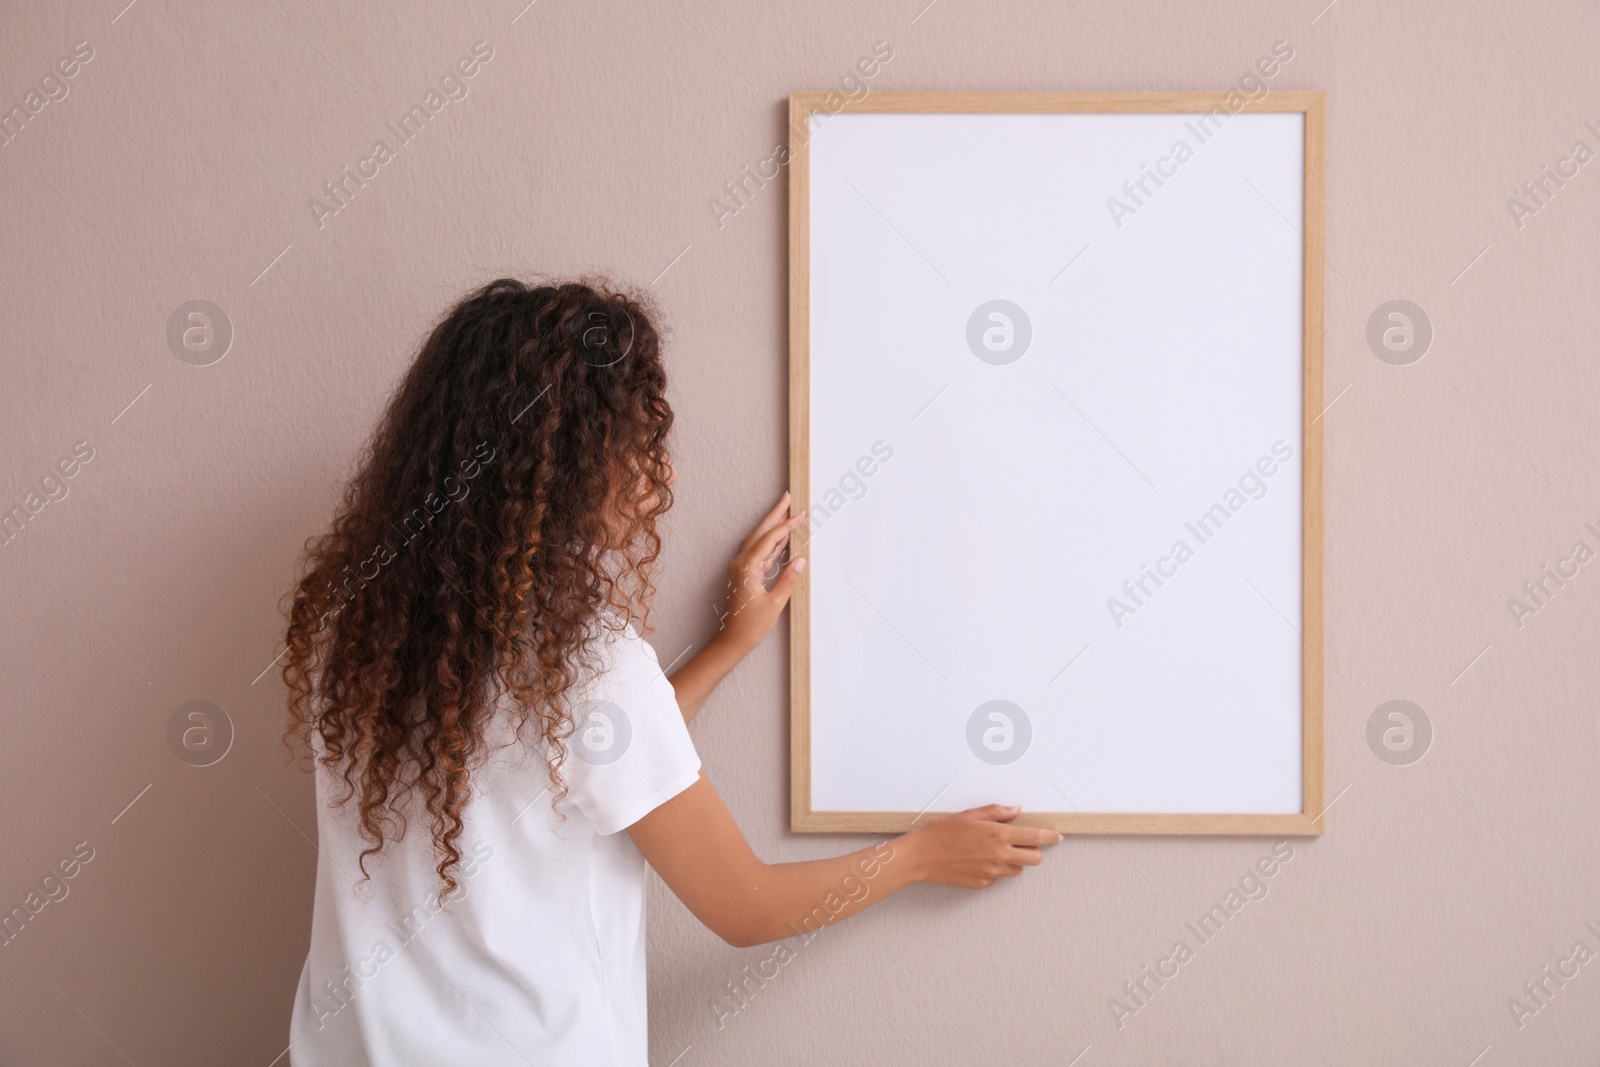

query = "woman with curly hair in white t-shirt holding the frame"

[{"left": 285, "top": 280, "right": 1059, "bottom": 1067}]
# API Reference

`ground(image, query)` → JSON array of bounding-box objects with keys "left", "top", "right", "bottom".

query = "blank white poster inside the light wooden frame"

[{"left": 803, "top": 112, "right": 1304, "bottom": 814}]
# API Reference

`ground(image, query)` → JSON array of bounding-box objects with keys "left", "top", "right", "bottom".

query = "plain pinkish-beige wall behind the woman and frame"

[{"left": 0, "top": 0, "right": 1600, "bottom": 1067}]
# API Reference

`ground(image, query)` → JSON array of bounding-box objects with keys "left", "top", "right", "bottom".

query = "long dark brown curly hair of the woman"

[{"left": 283, "top": 278, "right": 672, "bottom": 899}]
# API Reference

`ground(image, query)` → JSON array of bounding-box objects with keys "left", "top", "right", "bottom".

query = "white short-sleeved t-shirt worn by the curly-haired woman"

[{"left": 290, "top": 625, "right": 701, "bottom": 1067}]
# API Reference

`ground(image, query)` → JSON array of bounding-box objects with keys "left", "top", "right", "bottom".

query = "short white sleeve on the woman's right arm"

[{"left": 562, "top": 625, "right": 701, "bottom": 835}]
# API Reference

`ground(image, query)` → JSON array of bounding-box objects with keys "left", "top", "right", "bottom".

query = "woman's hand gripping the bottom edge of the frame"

[{"left": 894, "top": 805, "right": 1061, "bottom": 889}]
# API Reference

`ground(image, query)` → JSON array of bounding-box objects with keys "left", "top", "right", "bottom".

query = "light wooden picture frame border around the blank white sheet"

[{"left": 789, "top": 91, "right": 1325, "bottom": 835}]
